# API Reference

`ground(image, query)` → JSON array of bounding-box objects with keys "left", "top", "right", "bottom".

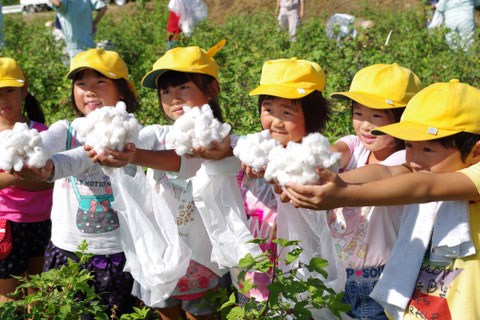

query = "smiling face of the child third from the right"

[{"left": 260, "top": 98, "right": 307, "bottom": 146}]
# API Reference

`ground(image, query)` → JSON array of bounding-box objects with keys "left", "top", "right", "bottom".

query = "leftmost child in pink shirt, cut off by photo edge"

[{"left": 0, "top": 58, "right": 52, "bottom": 302}]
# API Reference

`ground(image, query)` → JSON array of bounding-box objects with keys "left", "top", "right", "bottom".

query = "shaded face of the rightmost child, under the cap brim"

[{"left": 405, "top": 141, "right": 469, "bottom": 173}]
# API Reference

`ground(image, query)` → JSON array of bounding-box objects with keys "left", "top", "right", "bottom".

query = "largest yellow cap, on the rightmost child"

[{"left": 372, "top": 79, "right": 480, "bottom": 141}]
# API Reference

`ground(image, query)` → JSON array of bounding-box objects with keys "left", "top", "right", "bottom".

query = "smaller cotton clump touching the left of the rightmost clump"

[{"left": 233, "top": 130, "right": 280, "bottom": 171}]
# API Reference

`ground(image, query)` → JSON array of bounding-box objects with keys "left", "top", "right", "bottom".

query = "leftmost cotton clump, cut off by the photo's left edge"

[{"left": 0, "top": 122, "right": 50, "bottom": 171}]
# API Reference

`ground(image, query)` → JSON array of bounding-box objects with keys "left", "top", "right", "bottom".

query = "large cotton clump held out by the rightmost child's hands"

[{"left": 264, "top": 133, "right": 340, "bottom": 185}]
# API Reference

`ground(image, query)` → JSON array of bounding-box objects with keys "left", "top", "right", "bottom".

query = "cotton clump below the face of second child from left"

[{"left": 72, "top": 101, "right": 139, "bottom": 154}]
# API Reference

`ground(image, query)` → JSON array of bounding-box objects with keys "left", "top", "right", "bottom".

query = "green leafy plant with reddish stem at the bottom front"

[{"left": 211, "top": 239, "right": 350, "bottom": 320}]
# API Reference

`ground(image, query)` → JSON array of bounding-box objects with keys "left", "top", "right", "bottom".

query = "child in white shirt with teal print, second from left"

[{"left": 25, "top": 49, "right": 139, "bottom": 316}]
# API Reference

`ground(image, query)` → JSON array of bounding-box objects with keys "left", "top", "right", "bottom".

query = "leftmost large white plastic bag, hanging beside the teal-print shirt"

[{"left": 110, "top": 167, "right": 191, "bottom": 305}]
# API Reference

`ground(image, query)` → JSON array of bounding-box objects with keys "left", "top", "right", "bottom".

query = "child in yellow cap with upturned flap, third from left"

[{"left": 90, "top": 41, "right": 231, "bottom": 320}]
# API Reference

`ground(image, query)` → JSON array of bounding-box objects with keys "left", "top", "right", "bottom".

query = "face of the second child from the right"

[{"left": 352, "top": 102, "right": 395, "bottom": 152}]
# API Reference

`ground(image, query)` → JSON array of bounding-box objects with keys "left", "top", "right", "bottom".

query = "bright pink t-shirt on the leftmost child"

[{"left": 0, "top": 121, "right": 53, "bottom": 222}]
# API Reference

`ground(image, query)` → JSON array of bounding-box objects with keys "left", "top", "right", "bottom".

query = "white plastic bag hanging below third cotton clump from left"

[{"left": 192, "top": 157, "right": 262, "bottom": 268}]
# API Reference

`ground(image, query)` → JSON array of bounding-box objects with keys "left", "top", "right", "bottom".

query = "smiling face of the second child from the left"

[{"left": 73, "top": 69, "right": 122, "bottom": 115}]
